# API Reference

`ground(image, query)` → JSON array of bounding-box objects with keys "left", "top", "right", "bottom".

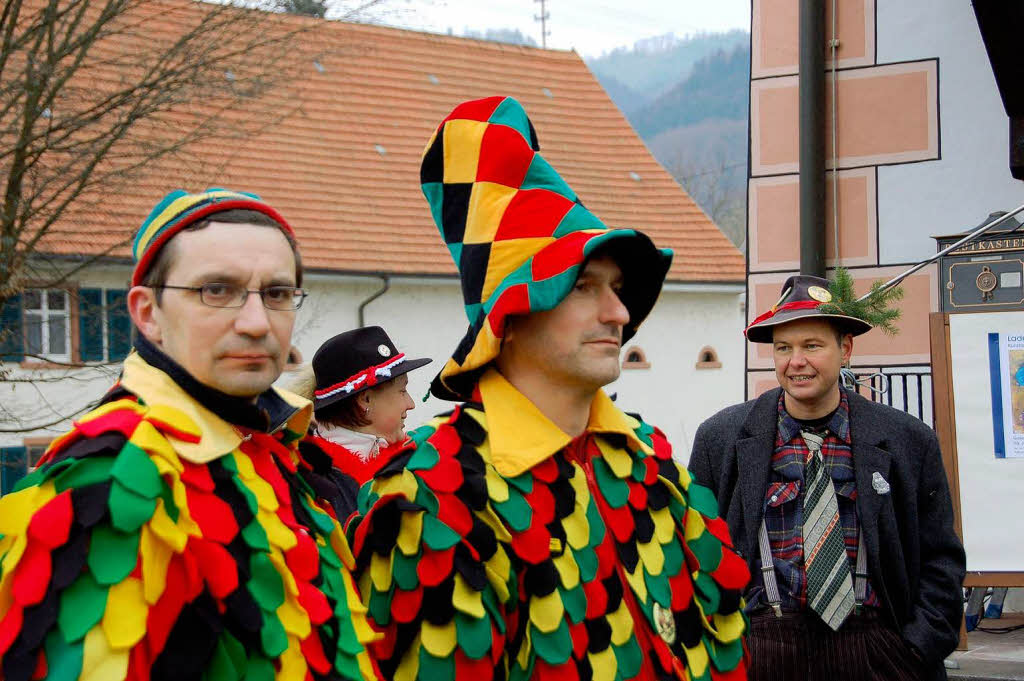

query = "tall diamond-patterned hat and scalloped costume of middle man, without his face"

[{"left": 347, "top": 97, "right": 750, "bottom": 681}]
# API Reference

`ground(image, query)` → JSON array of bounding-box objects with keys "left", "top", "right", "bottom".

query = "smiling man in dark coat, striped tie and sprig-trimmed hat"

[{"left": 689, "top": 270, "right": 965, "bottom": 681}]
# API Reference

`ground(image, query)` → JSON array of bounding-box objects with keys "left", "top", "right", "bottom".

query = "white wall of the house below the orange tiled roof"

[{"left": 6, "top": 268, "right": 743, "bottom": 461}]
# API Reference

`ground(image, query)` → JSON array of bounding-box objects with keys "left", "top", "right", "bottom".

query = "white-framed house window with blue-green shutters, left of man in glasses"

[{"left": 0, "top": 289, "right": 133, "bottom": 363}]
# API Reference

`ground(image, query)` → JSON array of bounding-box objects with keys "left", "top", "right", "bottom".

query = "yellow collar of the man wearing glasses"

[{"left": 121, "top": 352, "right": 313, "bottom": 464}]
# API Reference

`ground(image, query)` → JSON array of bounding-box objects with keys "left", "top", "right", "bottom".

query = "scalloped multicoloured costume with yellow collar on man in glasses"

[{"left": 0, "top": 187, "right": 379, "bottom": 681}]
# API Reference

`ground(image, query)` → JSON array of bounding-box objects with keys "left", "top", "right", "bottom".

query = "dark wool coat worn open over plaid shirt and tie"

[{"left": 689, "top": 388, "right": 966, "bottom": 679}]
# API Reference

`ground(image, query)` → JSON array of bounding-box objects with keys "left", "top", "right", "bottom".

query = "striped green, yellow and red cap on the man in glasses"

[{"left": 131, "top": 187, "right": 295, "bottom": 286}]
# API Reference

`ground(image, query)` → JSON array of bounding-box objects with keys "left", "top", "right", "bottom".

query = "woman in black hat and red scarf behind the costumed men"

[{"left": 292, "top": 327, "right": 431, "bottom": 520}]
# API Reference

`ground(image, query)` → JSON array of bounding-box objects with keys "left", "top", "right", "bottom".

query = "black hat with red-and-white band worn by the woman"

[{"left": 312, "top": 327, "right": 432, "bottom": 412}]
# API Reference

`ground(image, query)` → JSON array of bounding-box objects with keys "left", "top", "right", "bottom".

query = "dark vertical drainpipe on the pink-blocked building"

[{"left": 800, "top": 0, "right": 835, "bottom": 276}]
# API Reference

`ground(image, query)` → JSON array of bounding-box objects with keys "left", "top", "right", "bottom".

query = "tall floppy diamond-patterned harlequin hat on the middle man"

[{"left": 420, "top": 96, "right": 672, "bottom": 399}]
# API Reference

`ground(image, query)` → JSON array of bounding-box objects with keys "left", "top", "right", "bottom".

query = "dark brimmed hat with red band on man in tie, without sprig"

[{"left": 743, "top": 274, "right": 874, "bottom": 343}]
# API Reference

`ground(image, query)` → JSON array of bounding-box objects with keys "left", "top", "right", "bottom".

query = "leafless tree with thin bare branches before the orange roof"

[{"left": 0, "top": 0, "right": 407, "bottom": 435}]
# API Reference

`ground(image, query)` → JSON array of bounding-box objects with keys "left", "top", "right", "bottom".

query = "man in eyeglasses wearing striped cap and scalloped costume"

[{"left": 0, "top": 189, "right": 379, "bottom": 681}]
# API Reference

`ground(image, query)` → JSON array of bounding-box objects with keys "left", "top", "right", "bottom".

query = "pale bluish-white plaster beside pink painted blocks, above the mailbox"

[{"left": 877, "top": 0, "right": 1024, "bottom": 264}]
